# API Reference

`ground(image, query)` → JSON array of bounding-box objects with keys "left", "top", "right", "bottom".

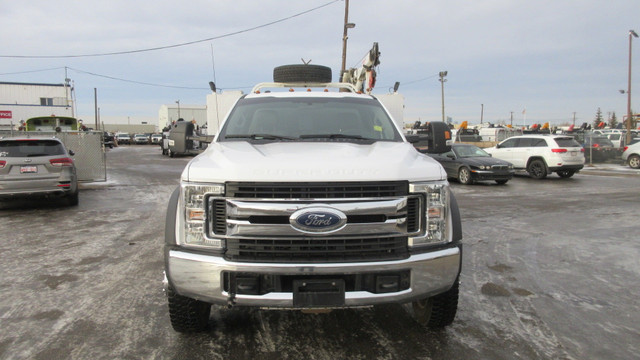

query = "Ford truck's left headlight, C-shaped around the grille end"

[{"left": 178, "top": 183, "right": 224, "bottom": 249}]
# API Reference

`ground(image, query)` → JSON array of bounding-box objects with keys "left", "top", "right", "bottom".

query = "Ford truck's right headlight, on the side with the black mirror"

[{"left": 409, "top": 181, "right": 451, "bottom": 247}]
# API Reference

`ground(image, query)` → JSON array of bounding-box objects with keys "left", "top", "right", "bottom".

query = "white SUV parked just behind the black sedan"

[{"left": 485, "top": 135, "right": 584, "bottom": 179}]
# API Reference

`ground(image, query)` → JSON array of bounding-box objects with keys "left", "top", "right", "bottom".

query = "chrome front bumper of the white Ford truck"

[{"left": 165, "top": 247, "right": 461, "bottom": 308}]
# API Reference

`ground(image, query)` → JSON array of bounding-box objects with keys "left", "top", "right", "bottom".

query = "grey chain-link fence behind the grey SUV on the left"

[{"left": 0, "top": 131, "right": 107, "bottom": 182}]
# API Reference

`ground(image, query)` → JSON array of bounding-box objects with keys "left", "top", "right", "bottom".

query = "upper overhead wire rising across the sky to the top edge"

[{"left": 0, "top": 0, "right": 341, "bottom": 59}]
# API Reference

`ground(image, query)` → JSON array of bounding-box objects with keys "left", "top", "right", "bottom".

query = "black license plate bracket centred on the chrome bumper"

[{"left": 293, "top": 279, "right": 345, "bottom": 308}]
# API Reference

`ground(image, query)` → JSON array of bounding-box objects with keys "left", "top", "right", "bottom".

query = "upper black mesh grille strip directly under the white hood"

[{"left": 226, "top": 181, "right": 409, "bottom": 199}]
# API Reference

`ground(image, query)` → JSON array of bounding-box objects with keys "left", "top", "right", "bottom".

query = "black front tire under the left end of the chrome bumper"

[{"left": 167, "top": 287, "right": 211, "bottom": 333}]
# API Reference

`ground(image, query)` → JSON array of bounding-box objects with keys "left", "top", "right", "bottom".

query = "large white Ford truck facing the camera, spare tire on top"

[{"left": 164, "top": 65, "right": 462, "bottom": 332}]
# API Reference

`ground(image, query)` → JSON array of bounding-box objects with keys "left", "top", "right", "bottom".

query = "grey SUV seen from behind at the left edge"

[{"left": 0, "top": 137, "right": 78, "bottom": 205}]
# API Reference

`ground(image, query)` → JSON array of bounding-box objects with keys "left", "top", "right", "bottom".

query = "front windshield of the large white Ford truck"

[{"left": 219, "top": 97, "right": 402, "bottom": 142}]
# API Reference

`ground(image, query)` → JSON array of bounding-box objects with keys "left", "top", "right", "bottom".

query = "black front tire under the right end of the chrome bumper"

[{"left": 412, "top": 279, "right": 460, "bottom": 329}]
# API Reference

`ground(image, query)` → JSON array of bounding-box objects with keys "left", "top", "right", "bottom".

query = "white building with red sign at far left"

[{"left": 0, "top": 82, "right": 74, "bottom": 129}]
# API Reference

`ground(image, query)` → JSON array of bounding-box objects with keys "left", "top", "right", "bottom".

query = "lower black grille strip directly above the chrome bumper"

[{"left": 225, "top": 236, "right": 409, "bottom": 263}]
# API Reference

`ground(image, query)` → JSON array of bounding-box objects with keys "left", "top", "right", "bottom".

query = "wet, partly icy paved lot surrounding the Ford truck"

[{"left": 0, "top": 146, "right": 640, "bottom": 359}]
